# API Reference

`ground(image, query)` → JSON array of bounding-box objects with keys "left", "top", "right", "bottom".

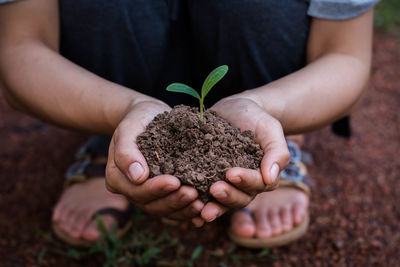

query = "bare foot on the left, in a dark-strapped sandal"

[{"left": 52, "top": 178, "right": 128, "bottom": 242}]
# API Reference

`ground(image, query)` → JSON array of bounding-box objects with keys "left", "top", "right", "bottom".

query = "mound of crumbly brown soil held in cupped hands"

[{"left": 137, "top": 105, "right": 264, "bottom": 202}]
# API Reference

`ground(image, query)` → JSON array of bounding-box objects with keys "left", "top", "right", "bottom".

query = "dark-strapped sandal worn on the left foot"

[{"left": 52, "top": 147, "right": 134, "bottom": 247}]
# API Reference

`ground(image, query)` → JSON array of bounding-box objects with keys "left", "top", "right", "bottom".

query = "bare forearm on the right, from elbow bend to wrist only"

[{"left": 246, "top": 50, "right": 370, "bottom": 134}]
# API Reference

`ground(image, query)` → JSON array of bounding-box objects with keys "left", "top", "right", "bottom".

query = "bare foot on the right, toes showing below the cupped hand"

[{"left": 231, "top": 187, "right": 309, "bottom": 238}]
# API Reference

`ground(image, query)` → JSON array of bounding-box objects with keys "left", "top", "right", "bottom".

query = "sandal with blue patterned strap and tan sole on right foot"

[{"left": 228, "top": 141, "right": 312, "bottom": 248}]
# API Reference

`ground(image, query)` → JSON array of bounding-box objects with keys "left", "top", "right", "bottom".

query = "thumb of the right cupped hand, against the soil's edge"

[{"left": 255, "top": 115, "right": 290, "bottom": 185}]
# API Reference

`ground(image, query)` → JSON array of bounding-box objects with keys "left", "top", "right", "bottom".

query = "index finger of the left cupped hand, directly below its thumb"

[{"left": 106, "top": 164, "right": 180, "bottom": 204}]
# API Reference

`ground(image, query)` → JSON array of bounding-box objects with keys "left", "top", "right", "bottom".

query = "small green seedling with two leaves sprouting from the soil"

[{"left": 167, "top": 65, "right": 228, "bottom": 122}]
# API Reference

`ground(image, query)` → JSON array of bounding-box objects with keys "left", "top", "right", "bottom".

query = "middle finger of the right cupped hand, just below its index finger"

[{"left": 210, "top": 181, "right": 253, "bottom": 208}]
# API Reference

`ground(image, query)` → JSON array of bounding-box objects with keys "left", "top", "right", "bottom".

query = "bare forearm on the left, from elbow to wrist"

[{"left": 0, "top": 40, "right": 150, "bottom": 133}]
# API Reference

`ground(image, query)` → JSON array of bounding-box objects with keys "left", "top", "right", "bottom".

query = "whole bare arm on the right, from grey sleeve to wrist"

[{"left": 239, "top": 9, "right": 373, "bottom": 134}]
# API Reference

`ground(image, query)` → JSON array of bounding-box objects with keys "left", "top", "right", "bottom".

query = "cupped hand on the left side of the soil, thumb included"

[{"left": 106, "top": 98, "right": 204, "bottom": 220}]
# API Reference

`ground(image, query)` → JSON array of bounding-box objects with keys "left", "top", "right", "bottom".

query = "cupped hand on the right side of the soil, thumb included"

[{"left": 193, "top": 94, "right": 290, "bottom": 226}]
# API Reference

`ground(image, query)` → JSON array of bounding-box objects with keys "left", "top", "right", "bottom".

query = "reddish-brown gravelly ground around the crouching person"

[{"left": 0, "top": 30, "right": 400, "bottom": 266}]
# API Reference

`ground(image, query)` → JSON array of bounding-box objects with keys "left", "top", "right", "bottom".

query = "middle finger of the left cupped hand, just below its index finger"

[{"left": 143, "top": 187, "right": 198, "bottom": 216}]
